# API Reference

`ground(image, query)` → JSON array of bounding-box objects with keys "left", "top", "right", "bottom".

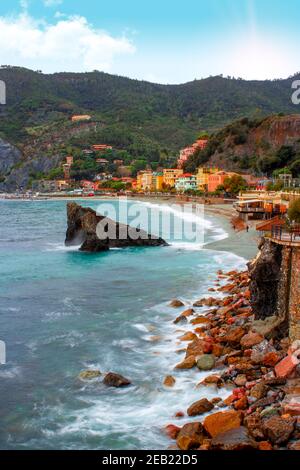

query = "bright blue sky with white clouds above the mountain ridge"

[{"left": 0, "top": 0, "right": 300, "bottom": 83}]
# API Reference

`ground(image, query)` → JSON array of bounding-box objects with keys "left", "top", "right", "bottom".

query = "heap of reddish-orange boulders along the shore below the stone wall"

[{"left": 165, "top": 268, "right": 300, "bottom": 450}]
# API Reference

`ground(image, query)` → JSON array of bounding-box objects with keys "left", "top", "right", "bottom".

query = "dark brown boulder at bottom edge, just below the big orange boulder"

[{"left": 211, "top": 426, "right": 257, "bottom": 450}]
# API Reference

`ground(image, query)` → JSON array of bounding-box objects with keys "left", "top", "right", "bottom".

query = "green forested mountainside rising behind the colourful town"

[{"left": 0, "top": 67, "right": 298, "bottom": 189}]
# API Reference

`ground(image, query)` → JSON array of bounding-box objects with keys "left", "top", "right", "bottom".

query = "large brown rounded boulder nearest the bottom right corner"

[{"left": 262, "top": 416, "right": 295, "bottom": 444}]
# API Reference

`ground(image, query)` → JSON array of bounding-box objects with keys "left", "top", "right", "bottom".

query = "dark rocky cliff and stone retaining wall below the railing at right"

[{"left": 248, "top": 239, "right": 300, "bottom": 340}]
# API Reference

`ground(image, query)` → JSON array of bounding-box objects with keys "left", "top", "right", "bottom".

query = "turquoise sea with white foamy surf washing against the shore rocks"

[{"left": 0, "top": 197, "right": 245, "bottom": 449}]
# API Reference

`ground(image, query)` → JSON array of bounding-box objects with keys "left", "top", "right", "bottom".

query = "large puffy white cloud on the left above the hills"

[{"left": 0, "top": 13, "right": 135, "bottom": 73}]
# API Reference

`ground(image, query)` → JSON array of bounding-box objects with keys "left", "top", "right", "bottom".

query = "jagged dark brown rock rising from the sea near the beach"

[{"left": 65, "top": 202, "right": 168, "bottom": 252}]
